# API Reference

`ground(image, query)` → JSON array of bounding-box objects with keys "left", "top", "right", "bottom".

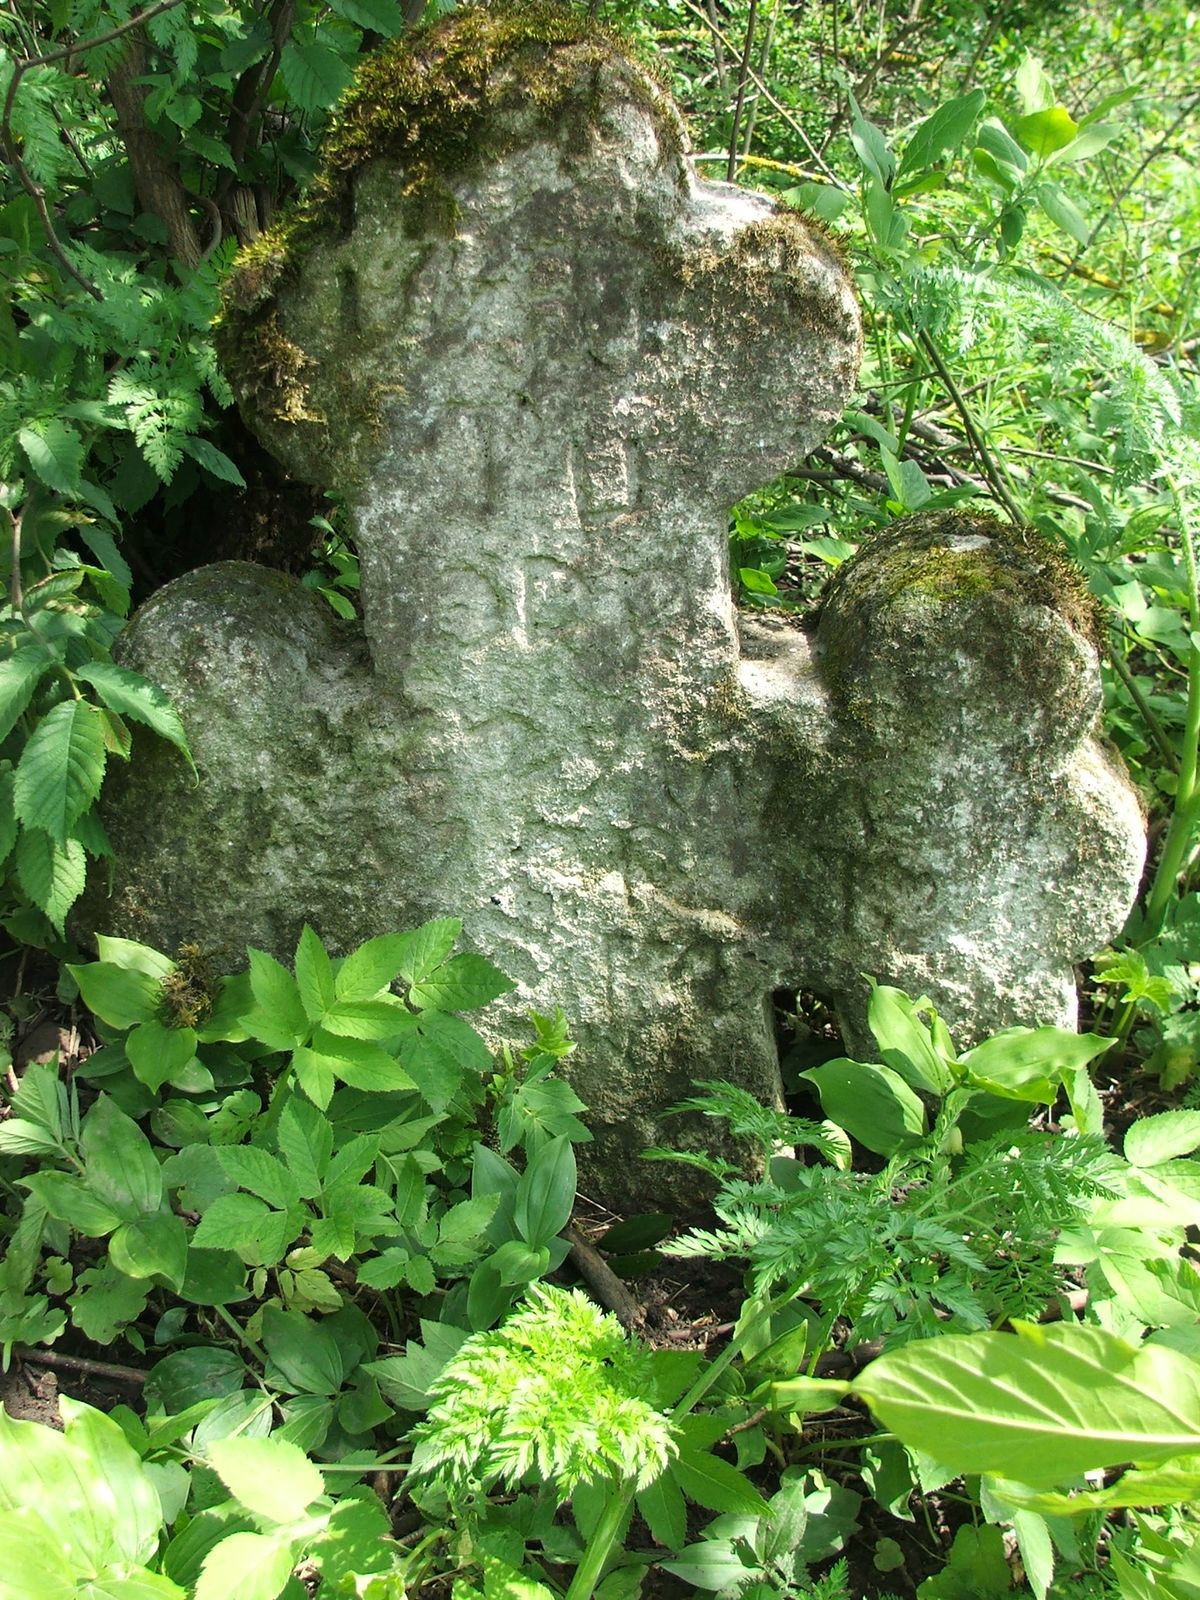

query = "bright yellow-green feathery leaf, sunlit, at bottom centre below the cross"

[{"left": 410, "top": 1283, "right": 677, "bottom": 1501}]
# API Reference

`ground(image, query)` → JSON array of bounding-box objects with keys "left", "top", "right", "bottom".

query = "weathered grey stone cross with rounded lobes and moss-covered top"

[{"left": 94, "top": 0, "right": 1142, "bottom": 1202}]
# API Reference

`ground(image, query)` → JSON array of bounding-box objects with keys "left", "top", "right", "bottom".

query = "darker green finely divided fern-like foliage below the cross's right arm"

[{"left": 659, "top": 1085, "right": 1107, "bottom": 1346}]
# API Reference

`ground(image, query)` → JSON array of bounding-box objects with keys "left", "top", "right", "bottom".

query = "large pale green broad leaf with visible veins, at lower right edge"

[{"left": 853, "top": 1322, "right": 1200, "bottom": 1488}]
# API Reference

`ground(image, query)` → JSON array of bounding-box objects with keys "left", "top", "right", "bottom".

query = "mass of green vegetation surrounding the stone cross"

[{"left": 0, "top": 0, "right": 1200, "bottom": 1600}]
